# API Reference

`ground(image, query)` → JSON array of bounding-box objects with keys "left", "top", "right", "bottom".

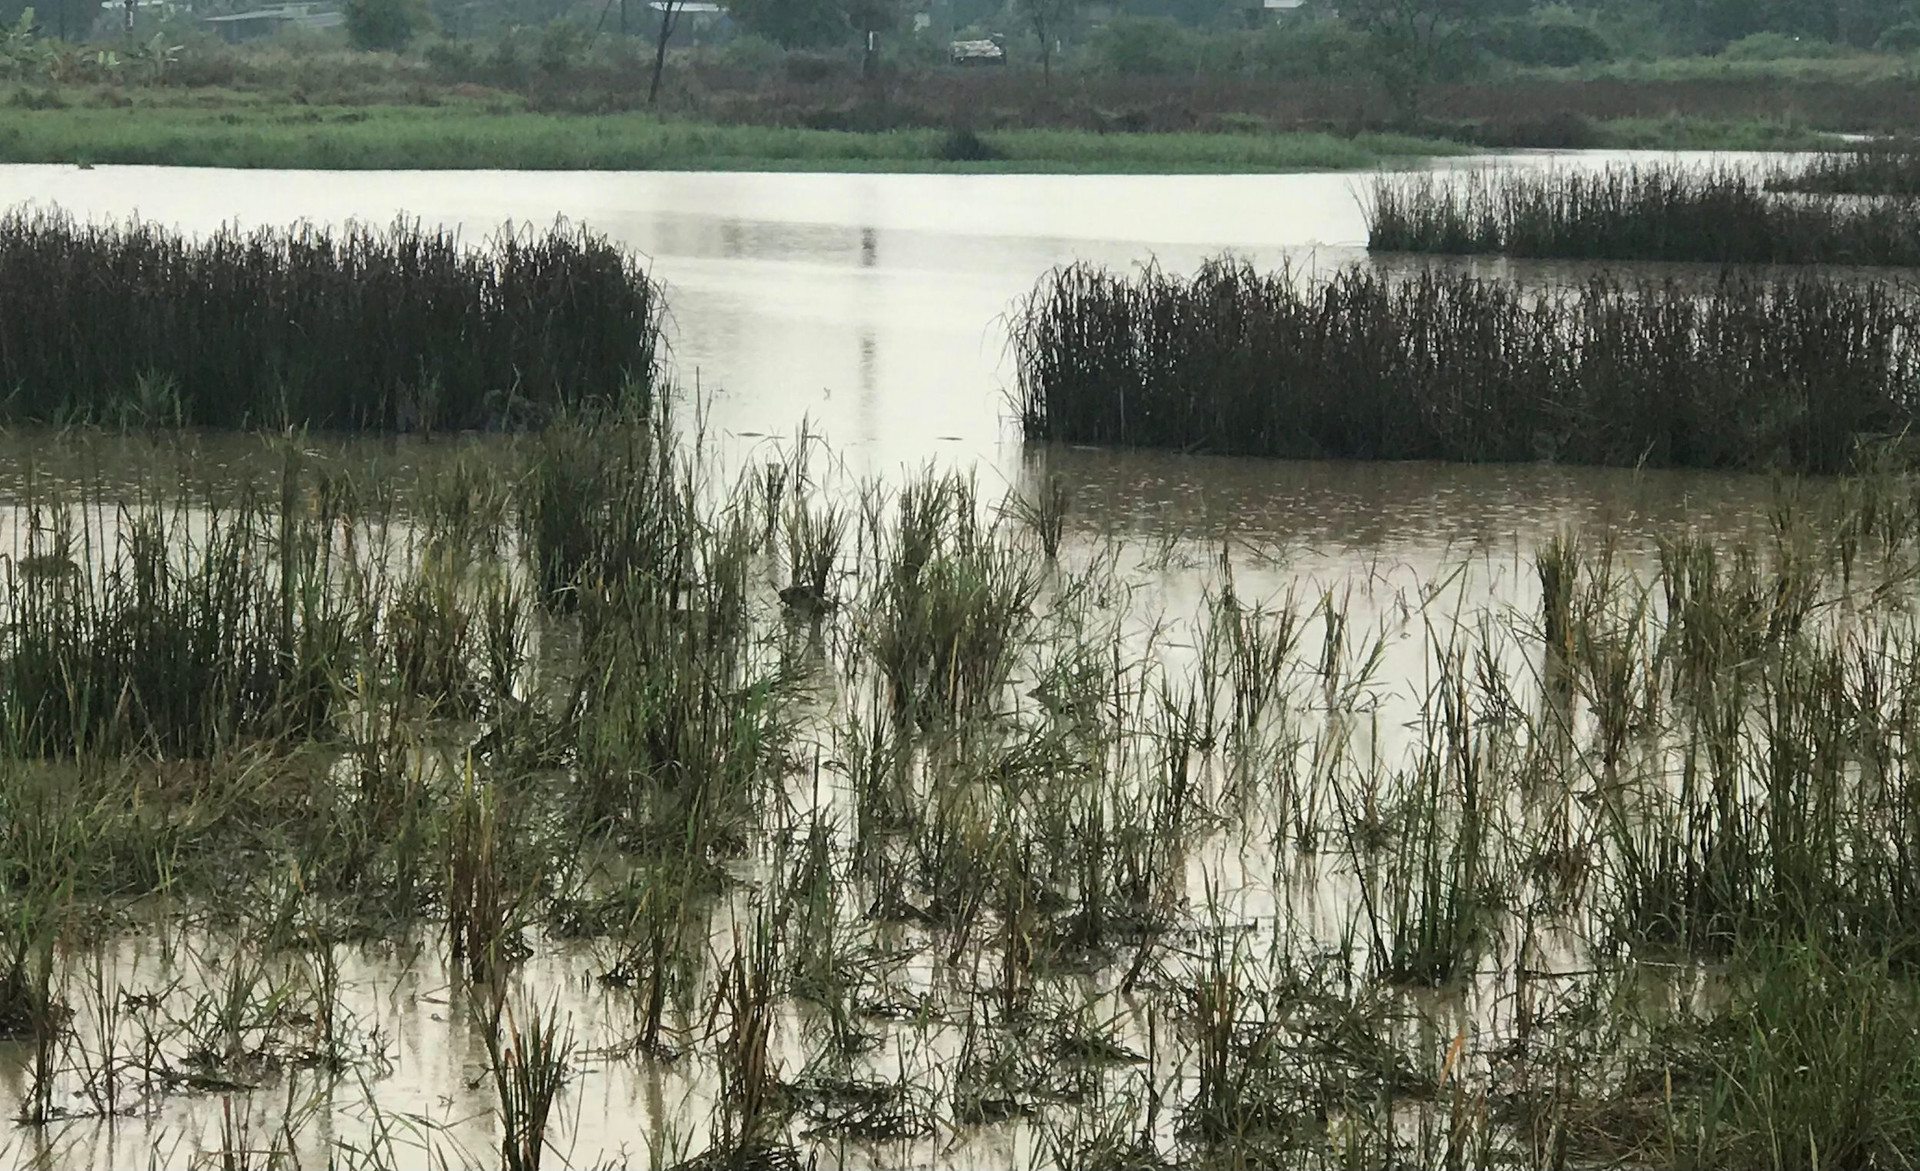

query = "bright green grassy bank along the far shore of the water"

[{"left": 0, "top": 104, "right": 1461, "bottom": 173}]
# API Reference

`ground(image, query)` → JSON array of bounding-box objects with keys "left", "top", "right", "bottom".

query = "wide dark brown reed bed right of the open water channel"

[{"left": 1014, "top": 261, "right": 1920, "bottom": 472}]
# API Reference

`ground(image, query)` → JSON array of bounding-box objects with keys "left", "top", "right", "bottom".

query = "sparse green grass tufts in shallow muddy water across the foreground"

[{"left": 11, "top": 405, "right": 1920, "bottom": 1171}]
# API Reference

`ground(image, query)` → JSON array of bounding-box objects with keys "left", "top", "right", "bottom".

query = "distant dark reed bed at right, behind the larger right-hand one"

[{"left": 1367, "top": 165, "right": 1920, "bottom": 267}]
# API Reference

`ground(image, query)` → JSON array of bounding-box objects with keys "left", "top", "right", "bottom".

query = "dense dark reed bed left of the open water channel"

[{"left": 0, "top": 211, "right": 660, "bottom": 430}]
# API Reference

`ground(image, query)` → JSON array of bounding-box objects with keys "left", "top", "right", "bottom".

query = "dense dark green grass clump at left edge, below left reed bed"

[{"left": 0, "top": 464, "right": 351, "bottom": 756}]
